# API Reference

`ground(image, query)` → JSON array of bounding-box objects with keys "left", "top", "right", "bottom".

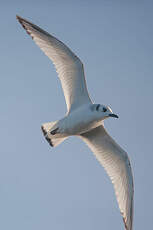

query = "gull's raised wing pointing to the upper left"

[{"left": 17, "top": 16, "right": 91, "bottom": 112}]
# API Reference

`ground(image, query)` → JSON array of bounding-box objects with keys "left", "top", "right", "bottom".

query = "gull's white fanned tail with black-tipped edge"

[{"left": 41, "top": 121, "right": 67, "bottom": 147}]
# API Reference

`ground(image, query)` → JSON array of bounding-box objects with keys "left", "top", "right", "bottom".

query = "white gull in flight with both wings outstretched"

[{"left": 16, "top": 16, "right": 134, "bottom": 230}]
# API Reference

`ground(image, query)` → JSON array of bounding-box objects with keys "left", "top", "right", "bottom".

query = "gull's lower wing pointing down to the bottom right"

[{"left": 81, "top": 126, "right": 134, "bottom": 230}]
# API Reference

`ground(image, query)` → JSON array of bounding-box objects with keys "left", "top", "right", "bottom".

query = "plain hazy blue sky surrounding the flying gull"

[{"left": 0, "top": 0, "right": 153, "bottom": 230}]
